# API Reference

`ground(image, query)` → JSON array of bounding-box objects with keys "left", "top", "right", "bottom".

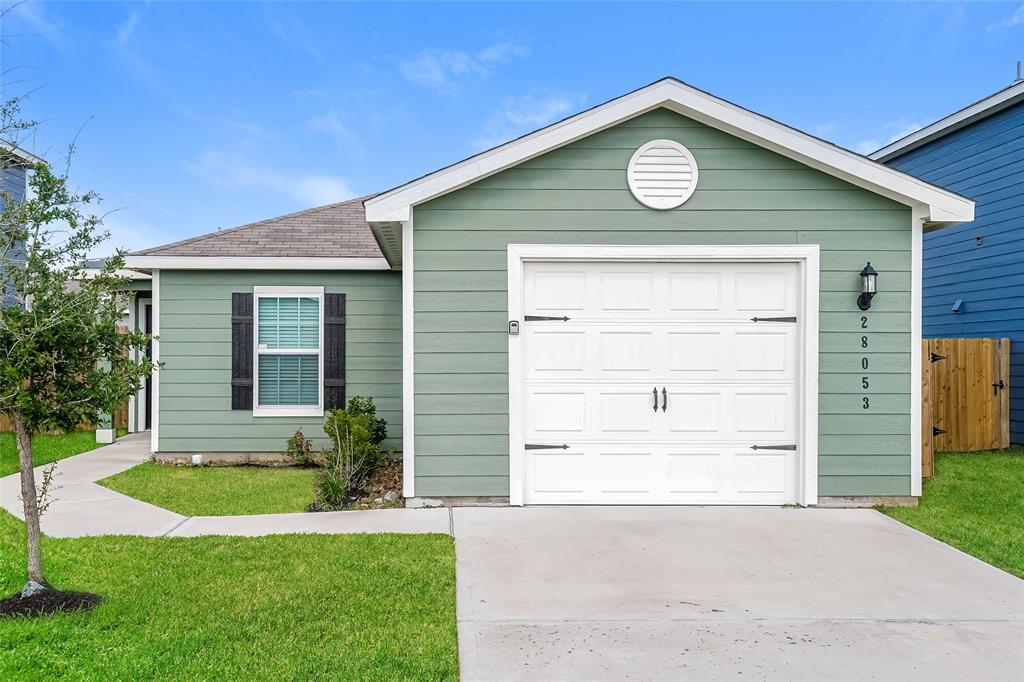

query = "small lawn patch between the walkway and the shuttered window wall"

[{"left": 99, "top": 462, "right": 313, "bottom": 516}]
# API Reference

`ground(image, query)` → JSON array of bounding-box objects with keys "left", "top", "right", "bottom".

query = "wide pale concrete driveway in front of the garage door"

[{"left": 454, "top": 507, "right": 1024, "bottom": 681}]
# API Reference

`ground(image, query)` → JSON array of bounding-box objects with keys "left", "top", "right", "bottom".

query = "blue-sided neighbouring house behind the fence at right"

[{"left": 870, "top": 80, "right": 1024, "bottom": 443}]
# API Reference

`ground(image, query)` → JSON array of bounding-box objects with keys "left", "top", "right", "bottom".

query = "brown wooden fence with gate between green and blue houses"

[{"left": 921, "top": 339, "right": 1010, "bottom": 477}]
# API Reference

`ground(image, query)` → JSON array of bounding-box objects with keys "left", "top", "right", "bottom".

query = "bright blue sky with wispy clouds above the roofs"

[{"left": 6, "top": 0, "right": 1024, "bottom": 249}]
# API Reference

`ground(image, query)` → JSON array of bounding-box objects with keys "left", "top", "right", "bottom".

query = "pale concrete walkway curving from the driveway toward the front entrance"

[{"left": 0, "top": 433, "right": 452, "bottom": 538}]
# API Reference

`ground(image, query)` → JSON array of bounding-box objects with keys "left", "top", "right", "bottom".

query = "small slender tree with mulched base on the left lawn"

[{"left": 0, "top": 155, "right": 152, "bottom": 596}]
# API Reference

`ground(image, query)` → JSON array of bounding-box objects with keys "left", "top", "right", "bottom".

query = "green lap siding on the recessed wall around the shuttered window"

[{"left": 160, "top": 270, "right": 401, "bottom": 452}]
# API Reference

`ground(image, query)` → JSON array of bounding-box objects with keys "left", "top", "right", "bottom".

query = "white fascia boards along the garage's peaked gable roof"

[{"left": 365, "top": 79, "right": 974, "bottom": 223}]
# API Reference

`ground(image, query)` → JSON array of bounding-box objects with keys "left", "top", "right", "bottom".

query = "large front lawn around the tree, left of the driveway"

[{"left": 0, "top": 512, "right": 458, "bottom": 681}]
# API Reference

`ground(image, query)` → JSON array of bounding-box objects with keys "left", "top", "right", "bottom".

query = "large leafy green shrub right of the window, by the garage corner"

[{"left": 312, "top": 395, "right": 387, "bottom": 510}]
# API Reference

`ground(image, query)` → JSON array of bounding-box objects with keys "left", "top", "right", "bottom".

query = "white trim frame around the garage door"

[{"left": 508, "top": 244, "right": 819, "bottom": 506}]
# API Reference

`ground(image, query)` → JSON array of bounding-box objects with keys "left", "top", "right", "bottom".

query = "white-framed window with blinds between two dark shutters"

[{"left": 253, "top": 280, "right": 324, "bottom": 417}]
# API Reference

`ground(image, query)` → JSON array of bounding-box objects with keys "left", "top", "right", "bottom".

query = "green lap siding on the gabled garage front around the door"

[{"left": 414, "top": 111, "right": 910, "bottom": 496}]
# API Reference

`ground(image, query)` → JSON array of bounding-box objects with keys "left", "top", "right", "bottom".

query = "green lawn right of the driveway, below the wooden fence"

[{"left": 883, "top": 447, "right": 1024, "bottom": 578}]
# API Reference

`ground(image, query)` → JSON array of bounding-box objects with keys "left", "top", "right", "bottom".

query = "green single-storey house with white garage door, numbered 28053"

[{"left": 128, "top": 79, "right": 974, "bottom": 505}]
